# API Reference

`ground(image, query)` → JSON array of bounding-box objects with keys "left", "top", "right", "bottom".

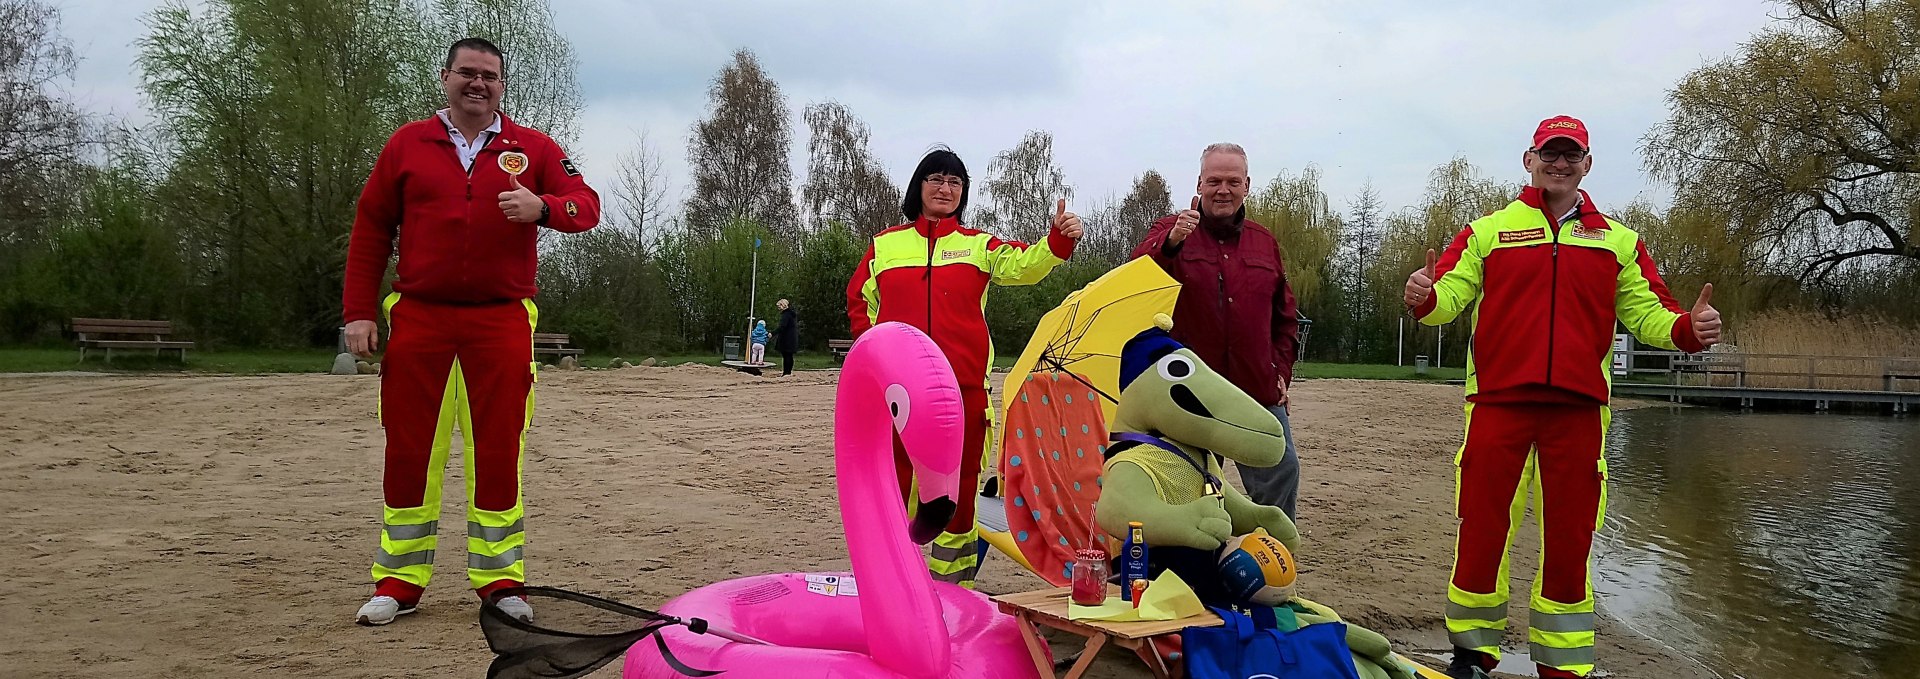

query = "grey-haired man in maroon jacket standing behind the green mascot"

[{"left": 1133, "top": 144, "right": 1300, "bottom": 518}]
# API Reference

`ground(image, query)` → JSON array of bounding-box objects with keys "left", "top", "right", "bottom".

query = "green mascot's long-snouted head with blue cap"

[{"left": 1114, "top": 315, "right": 1286, "bottom": 466}]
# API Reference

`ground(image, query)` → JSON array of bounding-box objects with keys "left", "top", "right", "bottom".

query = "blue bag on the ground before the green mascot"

[{"left": 1181, "top": 606, "right": 1359, "bottom": 679}]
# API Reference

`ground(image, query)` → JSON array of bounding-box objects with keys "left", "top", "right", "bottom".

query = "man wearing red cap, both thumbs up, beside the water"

[{"left": 1405, "top": 115, "right": 1720, "bottom": 679}]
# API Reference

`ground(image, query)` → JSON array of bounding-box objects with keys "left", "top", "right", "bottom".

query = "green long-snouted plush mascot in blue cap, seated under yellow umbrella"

[{"left": 1094, "top": 315, "right": 1411, "bottom": 679}]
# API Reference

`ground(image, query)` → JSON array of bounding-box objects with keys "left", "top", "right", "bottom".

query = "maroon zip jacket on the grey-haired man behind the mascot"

[{"left": 1133, "top": 209, "right": 1300, "bottom": 407}]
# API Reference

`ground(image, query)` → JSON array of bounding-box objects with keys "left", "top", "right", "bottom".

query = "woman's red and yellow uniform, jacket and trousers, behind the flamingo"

[{"left": 847, "top": 217, "right": 1077, "bottom": 587}]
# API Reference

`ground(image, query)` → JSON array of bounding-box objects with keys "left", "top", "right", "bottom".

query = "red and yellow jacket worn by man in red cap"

[{"left": 1413, "top": 188, "right": 1703, "bottom": 403}]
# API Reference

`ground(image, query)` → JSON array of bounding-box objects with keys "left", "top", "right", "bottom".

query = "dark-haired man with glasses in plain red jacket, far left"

[{"left": 342, "top": 38, "right": 599, "bottom": 625}]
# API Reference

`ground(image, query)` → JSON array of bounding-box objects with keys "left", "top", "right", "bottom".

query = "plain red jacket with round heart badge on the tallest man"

[{"left": 342, "top": 115, "right": 599, "bottom": 322}]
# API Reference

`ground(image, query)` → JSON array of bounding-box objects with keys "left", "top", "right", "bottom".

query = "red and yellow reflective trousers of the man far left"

[{"left": 372, "top": 293, "right": 540, "bottom": 602}]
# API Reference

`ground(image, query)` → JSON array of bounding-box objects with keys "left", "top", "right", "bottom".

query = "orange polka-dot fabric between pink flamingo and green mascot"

[{"left": 1000, "top": 372, "right": 1108, "bottom": 587}]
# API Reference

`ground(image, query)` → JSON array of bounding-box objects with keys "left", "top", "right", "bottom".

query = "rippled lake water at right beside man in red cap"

[{"left": 1596, "top": 409, "right": 1920, "bottom": 679}]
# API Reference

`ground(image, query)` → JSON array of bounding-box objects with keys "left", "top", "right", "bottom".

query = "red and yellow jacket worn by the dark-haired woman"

[{"left": 847, "top": 217, "right": 1075, "bottom": 387}]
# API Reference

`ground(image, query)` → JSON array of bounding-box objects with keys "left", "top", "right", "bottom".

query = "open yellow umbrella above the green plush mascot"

[{"left": 1000, "top": 257, "right": 1181, "bottom": 422}]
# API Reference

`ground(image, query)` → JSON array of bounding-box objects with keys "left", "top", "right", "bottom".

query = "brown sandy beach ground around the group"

[{"left": 0, "top": 366, "right": 1699, "bottom": 677}]
